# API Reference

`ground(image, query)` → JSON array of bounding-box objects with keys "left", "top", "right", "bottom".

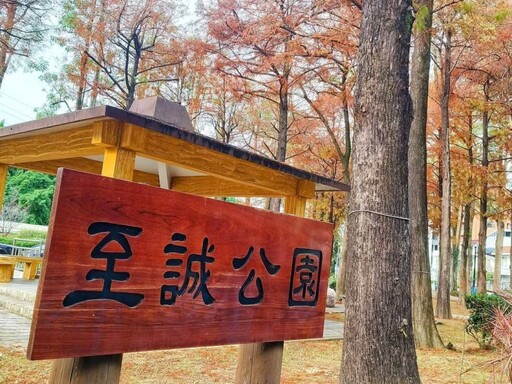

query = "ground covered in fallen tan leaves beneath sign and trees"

[{"left": 0, "top": 303, "right": 507, "bottom": 384}]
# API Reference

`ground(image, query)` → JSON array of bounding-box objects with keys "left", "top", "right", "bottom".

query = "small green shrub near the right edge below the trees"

[{"left": 466, "top": 293, "right": 512, "bottom": 349}]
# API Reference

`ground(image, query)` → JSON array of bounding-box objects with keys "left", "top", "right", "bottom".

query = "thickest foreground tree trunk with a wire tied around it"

[{"left": 340, "top": 0, "right": 420, "bottom": 384}]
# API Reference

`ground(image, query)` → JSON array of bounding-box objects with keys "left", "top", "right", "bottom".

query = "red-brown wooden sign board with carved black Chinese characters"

[{"left": 27, "top": 169, "right": 333, "bottom": 359}]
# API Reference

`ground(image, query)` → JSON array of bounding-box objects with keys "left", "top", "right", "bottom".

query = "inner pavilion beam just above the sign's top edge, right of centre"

[{"left": 171, "top": 176, "right": 283, "bottom": 197}]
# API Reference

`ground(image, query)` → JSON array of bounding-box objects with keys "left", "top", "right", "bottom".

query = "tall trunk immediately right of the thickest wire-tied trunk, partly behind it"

[{"left": 408, "top": 0, "right": 443, "bottom": 348}]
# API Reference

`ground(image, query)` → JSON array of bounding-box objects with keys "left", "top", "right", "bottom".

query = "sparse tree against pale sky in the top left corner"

[{"left": 0, "top": 0, "right": 50, "bottom": 88}]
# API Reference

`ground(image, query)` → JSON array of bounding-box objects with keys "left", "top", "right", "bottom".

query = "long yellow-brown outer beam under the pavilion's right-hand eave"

[{"left": 120, "top": 124, "right": 313, "bottom": 198}]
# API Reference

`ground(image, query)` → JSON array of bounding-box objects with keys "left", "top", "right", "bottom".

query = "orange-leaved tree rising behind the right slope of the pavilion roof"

[{"left": 203, "top": 0, "right": 354, "bottom": 162}]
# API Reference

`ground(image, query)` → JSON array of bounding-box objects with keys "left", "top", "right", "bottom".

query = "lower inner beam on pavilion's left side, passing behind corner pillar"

[{"left": 14, "top": 157, "right": 159, "bottom": 187}]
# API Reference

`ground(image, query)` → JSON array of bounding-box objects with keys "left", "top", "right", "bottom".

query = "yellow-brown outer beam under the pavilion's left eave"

[{"left": 0, "top": 126, "right": 103, "bottom": 164}]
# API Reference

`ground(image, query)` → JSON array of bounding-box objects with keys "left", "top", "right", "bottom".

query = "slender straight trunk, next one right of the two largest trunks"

[{"left": 437, "top": 30, "right": 452, "bottom": 319}]
